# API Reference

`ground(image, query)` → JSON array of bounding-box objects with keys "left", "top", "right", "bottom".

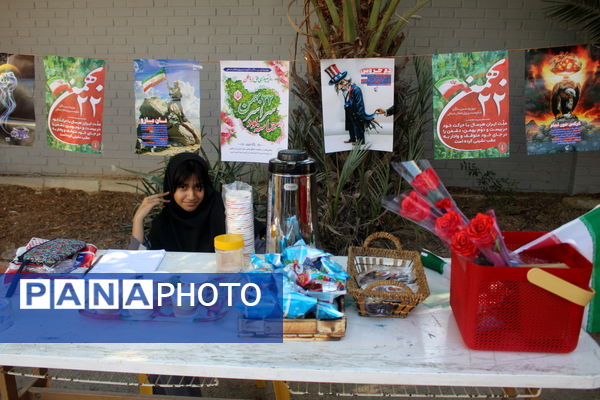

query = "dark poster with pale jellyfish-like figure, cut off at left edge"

[{"left": 0, "top": 53, "right": 35, "bottom": 146}]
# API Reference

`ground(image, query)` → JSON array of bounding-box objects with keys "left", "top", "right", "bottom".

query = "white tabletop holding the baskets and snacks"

[{"left": 0, "top": 253, "right": 600, "bottom": 400}]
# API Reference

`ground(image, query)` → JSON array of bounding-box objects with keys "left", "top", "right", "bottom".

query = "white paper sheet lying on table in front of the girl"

[{"left": 90, "top": 250, "right": 167, "bottom": 273}]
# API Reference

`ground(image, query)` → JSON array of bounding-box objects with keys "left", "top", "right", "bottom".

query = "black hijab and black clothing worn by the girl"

[{"left": 148, "top": 153, "right": 225, "bottom": 252}]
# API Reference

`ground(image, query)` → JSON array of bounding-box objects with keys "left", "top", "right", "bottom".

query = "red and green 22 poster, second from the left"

[{"left": 44, "top": 56, "right": 106, "bottom": 153}]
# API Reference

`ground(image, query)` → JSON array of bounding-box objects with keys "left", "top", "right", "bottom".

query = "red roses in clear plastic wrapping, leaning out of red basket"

[{"left": 382, "top": 160, "right": 520, "bottom": 265}]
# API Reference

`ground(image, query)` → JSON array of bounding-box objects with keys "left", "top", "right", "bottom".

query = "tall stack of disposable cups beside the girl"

[{"left": 223, "top": 182, "right": 254, "bottom": 271}]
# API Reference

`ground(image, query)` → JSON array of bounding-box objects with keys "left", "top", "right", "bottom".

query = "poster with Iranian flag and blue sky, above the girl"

[{"left": 133, "top": 59, "right": 202, "bottom": 156}]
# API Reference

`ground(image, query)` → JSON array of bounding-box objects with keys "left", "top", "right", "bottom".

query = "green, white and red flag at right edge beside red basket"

[{"left": 515, "top": 205, "right": 600, "bottom": 332}]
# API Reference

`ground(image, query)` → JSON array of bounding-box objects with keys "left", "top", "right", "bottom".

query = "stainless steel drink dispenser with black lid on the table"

[{"left": 267, "top": 150, "right": 317, "bottom": 253}]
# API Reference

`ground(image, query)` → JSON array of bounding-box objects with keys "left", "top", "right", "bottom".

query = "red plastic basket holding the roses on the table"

[{"left": 450, "top": 232, "right": 592, "bottom": 353}]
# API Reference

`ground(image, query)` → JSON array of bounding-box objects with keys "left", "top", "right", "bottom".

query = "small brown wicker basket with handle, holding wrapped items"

[{"left": 347, "top": 232, "right": 429, "bottom": 318}]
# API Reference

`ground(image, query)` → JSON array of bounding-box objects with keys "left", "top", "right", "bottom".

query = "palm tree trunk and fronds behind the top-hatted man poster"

[{"left": 288, "top": 0, "right": 431, "bottom": 254}]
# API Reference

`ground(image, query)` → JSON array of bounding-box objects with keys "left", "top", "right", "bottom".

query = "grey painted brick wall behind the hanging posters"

[{"left": 0, "top": 0, "right": 600, "bottom": 192}]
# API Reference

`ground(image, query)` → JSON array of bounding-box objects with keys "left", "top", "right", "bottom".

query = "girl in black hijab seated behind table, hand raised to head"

[{"left": 132, "top": 153, "right": 225, "bottom": 252}]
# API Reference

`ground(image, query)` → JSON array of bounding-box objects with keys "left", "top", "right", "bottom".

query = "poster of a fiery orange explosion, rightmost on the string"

[{"left": 525, "top": 46, "right": 600, "bottom": 154}]
